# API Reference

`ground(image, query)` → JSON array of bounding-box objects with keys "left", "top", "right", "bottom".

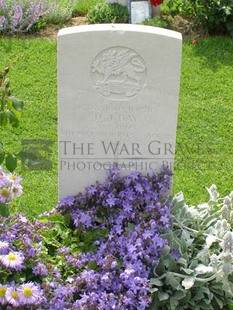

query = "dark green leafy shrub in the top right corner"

[{"left": 168, "top": 0, "right": 233, "bottom": 37}]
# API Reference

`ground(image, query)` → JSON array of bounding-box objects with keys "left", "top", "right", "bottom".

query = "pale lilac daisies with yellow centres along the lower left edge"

[{"left": 0, "top": 167, "right": 53, "bottom": 309}]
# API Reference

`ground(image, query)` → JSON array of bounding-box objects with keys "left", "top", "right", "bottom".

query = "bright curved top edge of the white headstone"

[{"left": 58, "top": 24, "right": 182, "bottom": 40}]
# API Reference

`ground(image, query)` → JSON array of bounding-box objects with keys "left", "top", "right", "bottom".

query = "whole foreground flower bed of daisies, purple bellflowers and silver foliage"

[{"left": 0, "top": 168, "right": 233, "bottom": 310}]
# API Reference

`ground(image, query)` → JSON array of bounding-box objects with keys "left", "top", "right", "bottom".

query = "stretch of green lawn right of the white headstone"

[{"left": 174, "top": 37, "right": 233, "bottom": 203}]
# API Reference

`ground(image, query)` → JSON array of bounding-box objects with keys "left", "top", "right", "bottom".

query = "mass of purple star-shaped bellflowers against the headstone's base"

[{"left": 39, "top": 167, "right": 171, "bottom": 310}]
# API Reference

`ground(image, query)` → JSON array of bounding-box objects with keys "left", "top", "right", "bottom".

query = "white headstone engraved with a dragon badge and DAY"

[{"left": 58, "top": 24, "right": 182, "bottom": 198}]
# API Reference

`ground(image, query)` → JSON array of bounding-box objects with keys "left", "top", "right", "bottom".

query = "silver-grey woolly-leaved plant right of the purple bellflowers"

[{"left": 150, "top": 185, "right": 233, "bottom": 310}]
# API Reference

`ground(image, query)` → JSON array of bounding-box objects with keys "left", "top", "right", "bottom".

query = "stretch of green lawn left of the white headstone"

[{"left": 0, "top": 39, "right": 57, "bottom": 216}]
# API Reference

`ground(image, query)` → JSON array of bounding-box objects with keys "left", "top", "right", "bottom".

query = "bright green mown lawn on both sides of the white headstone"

[{"left": 0, "top": 37, "right": 233, "bottom": 217}]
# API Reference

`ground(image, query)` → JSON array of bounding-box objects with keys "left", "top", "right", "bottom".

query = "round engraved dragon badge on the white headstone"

[{"left": 91, "top": 46, "right": 147, "bottom": 100}]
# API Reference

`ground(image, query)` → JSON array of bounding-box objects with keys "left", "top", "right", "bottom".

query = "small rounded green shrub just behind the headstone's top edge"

[{"left": 87, "top": 3, "right": 129, "bottom": 24}]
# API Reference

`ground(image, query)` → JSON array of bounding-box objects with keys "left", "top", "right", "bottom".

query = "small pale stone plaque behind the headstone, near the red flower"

[{"left": 130, "top": 1, "right": 151, "bottom": 24}]
